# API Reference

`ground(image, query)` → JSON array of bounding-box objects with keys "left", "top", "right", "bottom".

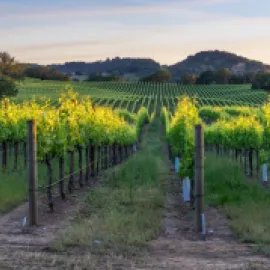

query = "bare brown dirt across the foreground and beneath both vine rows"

[{"left": 0, "top": 122, "right": 270, "bottom": 270}]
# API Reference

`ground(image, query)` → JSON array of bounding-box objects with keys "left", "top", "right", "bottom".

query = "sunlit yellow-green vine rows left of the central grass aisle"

[{"left": 0, "top": 91, "right": 150, "bottom": 215}]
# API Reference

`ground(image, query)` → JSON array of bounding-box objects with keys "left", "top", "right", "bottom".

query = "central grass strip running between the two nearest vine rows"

[{"left": 54, "top": 120, "right": 168, "bottom": 251}]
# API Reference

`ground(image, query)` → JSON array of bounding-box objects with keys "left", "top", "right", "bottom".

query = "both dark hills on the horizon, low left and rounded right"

[{"left": 49, "top": 51, "right": 270, "bottom": 81}]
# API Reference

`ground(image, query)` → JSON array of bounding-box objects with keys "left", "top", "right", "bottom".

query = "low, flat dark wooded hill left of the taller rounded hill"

[{"left": 50, "top": 57, "right": 160, "bottom": 78}]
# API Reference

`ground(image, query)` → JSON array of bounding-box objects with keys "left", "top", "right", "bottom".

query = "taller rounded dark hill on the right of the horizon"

[{"left": 168, "top": 51, "right": 270, "bottom": 80}]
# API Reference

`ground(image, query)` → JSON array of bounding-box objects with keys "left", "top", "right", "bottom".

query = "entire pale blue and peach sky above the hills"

[{"left": 0, "top": 0, "right": 270, "bottom": 64}]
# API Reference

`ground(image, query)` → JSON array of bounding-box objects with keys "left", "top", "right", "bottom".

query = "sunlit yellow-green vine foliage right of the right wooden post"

[{"left": 200, "top": 105, "right": 264, "bottom": 149}]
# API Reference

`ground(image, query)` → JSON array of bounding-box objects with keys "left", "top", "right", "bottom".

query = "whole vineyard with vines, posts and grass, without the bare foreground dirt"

[{"left": 0, "top": 80, "right": 270, "bottom": 269}]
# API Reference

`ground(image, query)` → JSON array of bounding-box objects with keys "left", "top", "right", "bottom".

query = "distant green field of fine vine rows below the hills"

[{"left": 16, "top": 80, "right": 268, "bottom": 113}]
